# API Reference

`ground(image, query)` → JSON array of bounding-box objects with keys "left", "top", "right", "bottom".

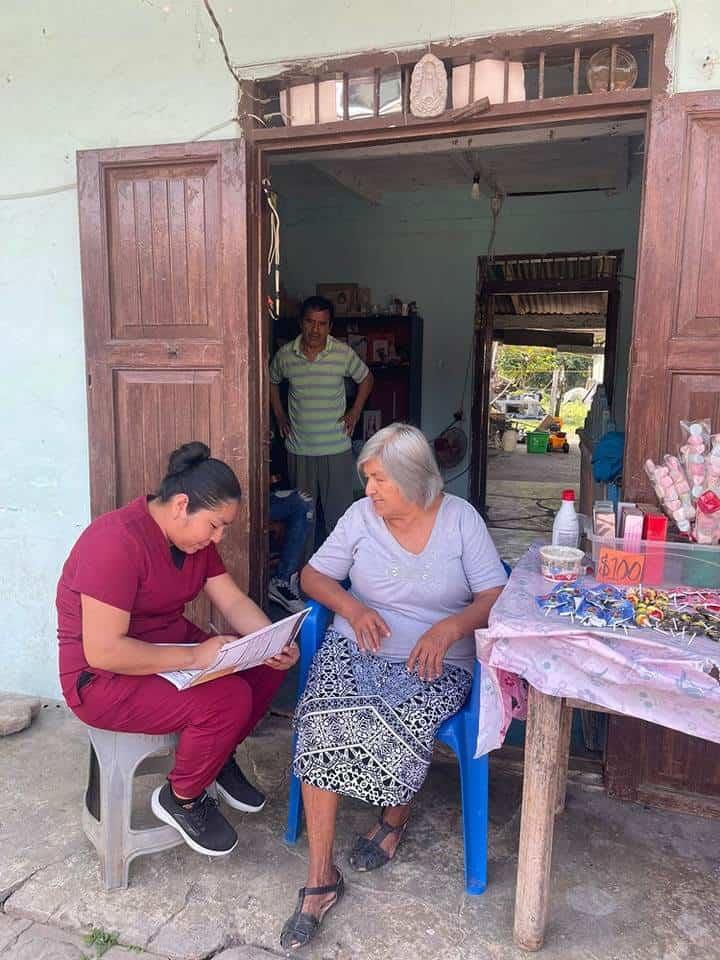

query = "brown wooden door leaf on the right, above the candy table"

[{"left": 623, "top": 92, "right": 720, "bottom": 500}]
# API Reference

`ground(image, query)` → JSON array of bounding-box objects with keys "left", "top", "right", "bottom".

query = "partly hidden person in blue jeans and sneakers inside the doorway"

[{"left": 268, "top": 432, "right": 315, "bottom": 613}]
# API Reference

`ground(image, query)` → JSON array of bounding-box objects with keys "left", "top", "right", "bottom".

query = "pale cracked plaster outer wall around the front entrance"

[{"left": 0, "top": 0, "right": 720, "bottom": 696}]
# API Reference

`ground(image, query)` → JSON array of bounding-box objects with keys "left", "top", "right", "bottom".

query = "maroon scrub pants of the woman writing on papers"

[{"left": 71, "top": 666, "right": 285, "bottom": 797}]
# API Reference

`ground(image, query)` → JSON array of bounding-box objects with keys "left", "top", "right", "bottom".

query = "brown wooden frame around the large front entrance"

[{"left": 245, "top": 14, "right": 675, "bottom": 584}]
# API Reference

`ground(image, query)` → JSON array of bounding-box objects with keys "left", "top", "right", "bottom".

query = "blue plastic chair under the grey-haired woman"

[{"left": 285, "top": 564, "right": 510, "bottom": 896}]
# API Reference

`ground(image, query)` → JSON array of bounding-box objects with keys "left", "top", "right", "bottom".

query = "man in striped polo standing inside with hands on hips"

[{"left": 270, "top": 297, "right": 373, "bottom": 556}]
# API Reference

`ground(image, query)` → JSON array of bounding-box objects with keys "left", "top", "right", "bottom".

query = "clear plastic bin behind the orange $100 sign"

[{"left": 587, "top": 532, "right": 720, "bottom": 590}]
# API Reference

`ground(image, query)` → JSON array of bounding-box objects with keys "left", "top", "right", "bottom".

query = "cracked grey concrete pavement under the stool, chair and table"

[{"left": 0, "top": 703, "right": 720, "bottom": 960}]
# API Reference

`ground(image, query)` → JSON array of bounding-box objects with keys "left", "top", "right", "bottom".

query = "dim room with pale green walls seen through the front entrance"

[{"left": 268, "top": 117, "right": 644, "bottom": 561}]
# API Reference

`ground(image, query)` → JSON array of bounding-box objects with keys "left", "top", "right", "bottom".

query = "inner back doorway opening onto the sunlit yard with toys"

[{"left": 471, "top": 250, "right": 623, "bottom": 559}]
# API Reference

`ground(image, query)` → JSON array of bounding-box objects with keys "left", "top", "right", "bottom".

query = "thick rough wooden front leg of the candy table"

[{"left": 513, "top": 686, "right": 563, "bottom": 950}]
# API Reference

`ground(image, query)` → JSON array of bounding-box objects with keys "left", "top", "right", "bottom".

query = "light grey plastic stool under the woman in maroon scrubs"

[{"left": 82, "top": 727, "right": 183, "bottom": 890}]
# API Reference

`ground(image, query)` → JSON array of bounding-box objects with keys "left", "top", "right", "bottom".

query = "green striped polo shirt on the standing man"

[{"left": 270, "top": 336, "right": 370, "bottom": 457}]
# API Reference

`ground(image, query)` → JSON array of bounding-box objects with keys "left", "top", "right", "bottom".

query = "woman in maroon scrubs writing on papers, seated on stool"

[{"left": 56, "top": 442, "right": 298, "bottom": 856}]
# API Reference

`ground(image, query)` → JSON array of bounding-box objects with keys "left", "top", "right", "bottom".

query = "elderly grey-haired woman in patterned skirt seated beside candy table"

[{"left": 281, "top": 423, "right": 507, "bottom": 949}]
